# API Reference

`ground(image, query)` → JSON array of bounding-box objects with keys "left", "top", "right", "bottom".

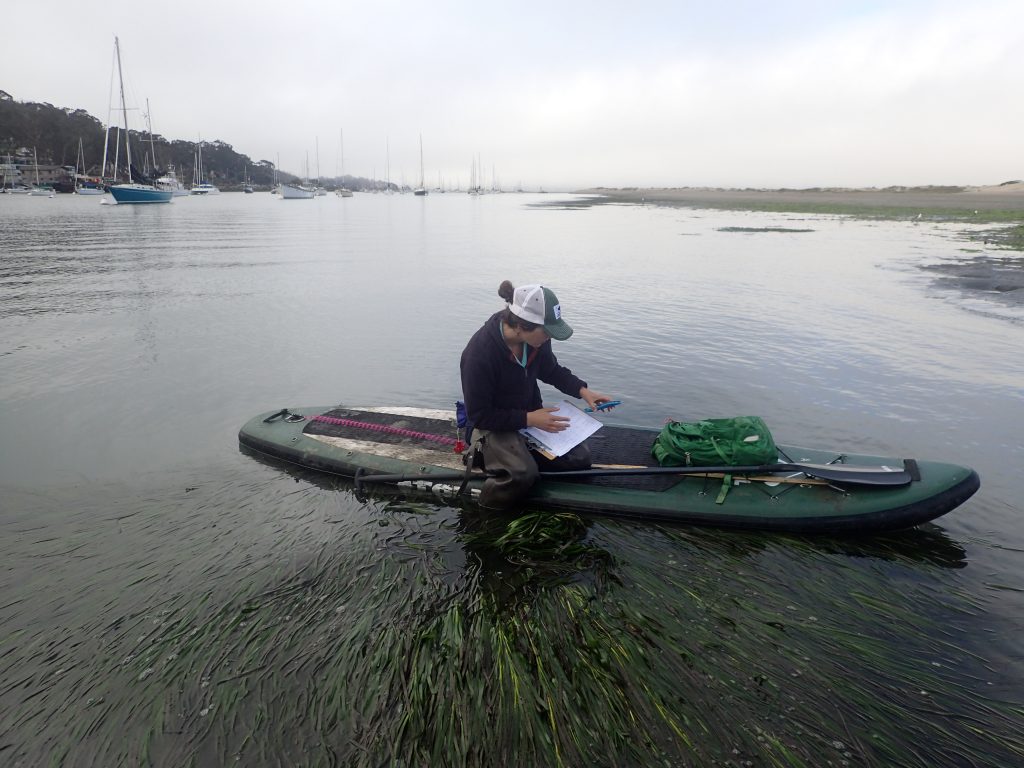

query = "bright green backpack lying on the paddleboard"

[{"left": 650, "top": 416, "right": 778, "bottom": 467}]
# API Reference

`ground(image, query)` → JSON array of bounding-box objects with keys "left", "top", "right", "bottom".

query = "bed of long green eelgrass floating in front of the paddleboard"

[{"left": 61, "top": 504, "right": 1024, "bottom": 768}]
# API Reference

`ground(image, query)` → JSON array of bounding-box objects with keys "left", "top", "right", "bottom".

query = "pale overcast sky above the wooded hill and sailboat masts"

[{"left": 8, "top": 0, "right": 1024, "bottom": 189}]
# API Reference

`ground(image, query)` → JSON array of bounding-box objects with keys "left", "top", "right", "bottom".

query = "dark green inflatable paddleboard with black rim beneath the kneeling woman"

[{"left": 239, "top": 406, "right": 980, "bottom": 534}]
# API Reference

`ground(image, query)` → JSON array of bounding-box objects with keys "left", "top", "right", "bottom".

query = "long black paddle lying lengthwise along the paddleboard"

[{"left": 355, "top": 463, "right": 914, "bottom": 486}]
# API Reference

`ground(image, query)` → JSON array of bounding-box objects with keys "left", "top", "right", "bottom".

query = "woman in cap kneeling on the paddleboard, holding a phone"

[{"left": 461, "top": 281, "right": 611, "bottom": 509}]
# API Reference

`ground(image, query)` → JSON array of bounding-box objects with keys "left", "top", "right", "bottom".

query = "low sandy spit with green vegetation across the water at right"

[{"left": 580, "top": 182, "right": 1024, "bottom": 213}]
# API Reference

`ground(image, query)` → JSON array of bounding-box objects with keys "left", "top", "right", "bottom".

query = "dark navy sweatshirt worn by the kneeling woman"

[{"left": 460, "top": 310, "right": 587, "bottom": 432}]
